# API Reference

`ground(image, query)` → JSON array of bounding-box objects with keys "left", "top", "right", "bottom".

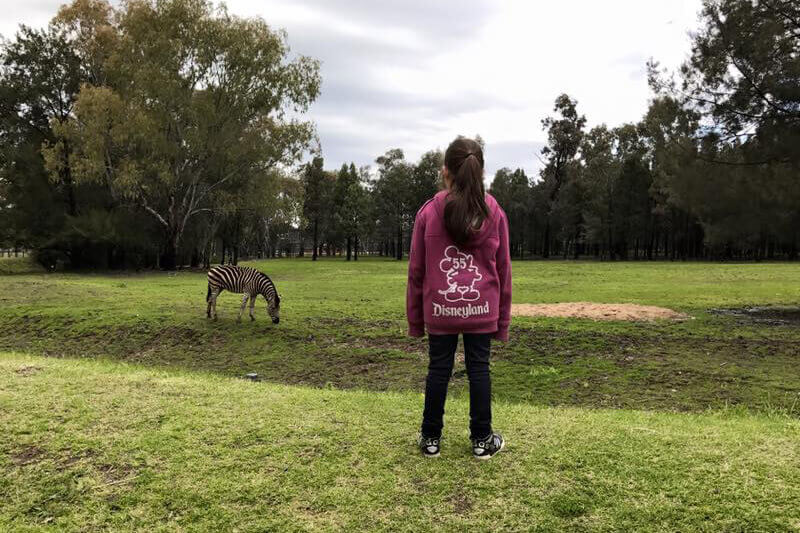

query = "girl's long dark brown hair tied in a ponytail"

[{"left": 444, "top": 137, "right": 489, "bottom": 245}]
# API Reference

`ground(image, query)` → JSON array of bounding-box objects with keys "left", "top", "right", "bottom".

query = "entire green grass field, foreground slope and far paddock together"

[{"left": 0, "top": 259, "right": 800, "bottom": 531}]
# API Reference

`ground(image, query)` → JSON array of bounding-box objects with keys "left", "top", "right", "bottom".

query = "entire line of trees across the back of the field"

[{"left": 0, "top": 0, "right": 800, "bottom": 268}]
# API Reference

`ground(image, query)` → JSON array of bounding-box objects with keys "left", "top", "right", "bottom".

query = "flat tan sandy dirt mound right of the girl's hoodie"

[{"left": 511, "top": 302, "right": 691, "bottom": 322}]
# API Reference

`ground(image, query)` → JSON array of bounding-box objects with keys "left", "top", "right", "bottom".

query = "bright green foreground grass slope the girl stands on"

[{"left": 0, "top": 353, "right": 800, "bottom": 531}]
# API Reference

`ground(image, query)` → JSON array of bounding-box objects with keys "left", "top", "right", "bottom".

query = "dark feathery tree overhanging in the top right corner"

[{"left": 650, "top": 0, "right": 800, "bottom": 168}]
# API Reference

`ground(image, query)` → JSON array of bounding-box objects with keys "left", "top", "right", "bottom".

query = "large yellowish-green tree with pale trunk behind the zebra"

[{"left": 44, "top": 0, "right": 319, "bottom": 269}]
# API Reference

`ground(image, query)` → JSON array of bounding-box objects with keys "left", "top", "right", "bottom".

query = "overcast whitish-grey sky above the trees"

[{"left": 0, "top": 0, "right": 700, "bottom": 179}]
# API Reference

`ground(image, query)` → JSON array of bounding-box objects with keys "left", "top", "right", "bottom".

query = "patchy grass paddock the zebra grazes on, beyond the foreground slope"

[{"left": 0, "top": 259, "right": 800, "bottom": 413}]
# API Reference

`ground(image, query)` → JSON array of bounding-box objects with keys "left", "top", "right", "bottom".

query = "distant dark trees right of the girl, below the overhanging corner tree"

[{"left": 491, "top": 95, "right": 800, "bottom": 260}]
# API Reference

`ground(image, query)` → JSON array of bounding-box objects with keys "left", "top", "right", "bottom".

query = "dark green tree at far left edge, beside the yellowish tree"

[{"left": 0, "top": 17, "right": 114, "bottom": 267}]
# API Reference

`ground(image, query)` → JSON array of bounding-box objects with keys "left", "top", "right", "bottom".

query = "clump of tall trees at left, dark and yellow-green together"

[{"left": 0, "top": 0, "right": 320, "bottom": 269}]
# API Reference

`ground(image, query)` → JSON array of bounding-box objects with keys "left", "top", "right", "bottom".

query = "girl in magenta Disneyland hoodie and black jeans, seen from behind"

[{"left": 406, "top": 137, "right": 511, "bottom": 459}]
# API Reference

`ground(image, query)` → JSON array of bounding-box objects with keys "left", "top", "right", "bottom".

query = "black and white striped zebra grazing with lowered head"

[{"left": 206, "top": 265, "right": 281, "bottom": 324}]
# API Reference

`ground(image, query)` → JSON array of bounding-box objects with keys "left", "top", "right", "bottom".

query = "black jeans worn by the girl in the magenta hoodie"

[{"left": 422, "top": 333, "right": 492, "bottom": 438}]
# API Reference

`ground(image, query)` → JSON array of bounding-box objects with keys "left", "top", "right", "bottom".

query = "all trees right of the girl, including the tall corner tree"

[{"left": 488, "top": 0, "right": 800, "bottom": 260}]
